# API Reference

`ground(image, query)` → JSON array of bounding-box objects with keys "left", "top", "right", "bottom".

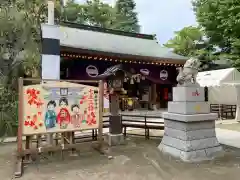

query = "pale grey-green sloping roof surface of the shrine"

[{"left": 60, "top": 24, "right": 187, "bottom": 61}]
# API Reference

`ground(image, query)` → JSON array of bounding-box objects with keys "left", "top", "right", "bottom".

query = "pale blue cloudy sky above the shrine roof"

[{"left": 77, "top": 0, "right": 197, "bottom": 44}]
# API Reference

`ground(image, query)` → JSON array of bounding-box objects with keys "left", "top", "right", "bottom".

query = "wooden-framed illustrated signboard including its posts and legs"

[{"left": 15, "top": 78, "right": 104, "bottom": 177}]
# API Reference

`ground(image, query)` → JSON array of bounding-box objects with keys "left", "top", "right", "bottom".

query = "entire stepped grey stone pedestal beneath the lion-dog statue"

[{"left": 158, "top": 86, "right": 222, "bottom": 162}]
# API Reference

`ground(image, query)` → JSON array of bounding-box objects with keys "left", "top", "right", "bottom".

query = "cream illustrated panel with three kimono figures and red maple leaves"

[{"left": 23, "top": 82, "right": 99, "bottom": 135}]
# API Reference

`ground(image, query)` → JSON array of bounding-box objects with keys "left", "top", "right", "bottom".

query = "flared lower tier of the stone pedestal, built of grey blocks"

[{"left": 158, "top": 119, "right": 222, "bottom": 162}]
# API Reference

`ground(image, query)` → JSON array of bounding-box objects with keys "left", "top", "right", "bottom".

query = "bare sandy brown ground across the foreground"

[{"left": 0, "top": 137, "right": 240, "bottom": 180}]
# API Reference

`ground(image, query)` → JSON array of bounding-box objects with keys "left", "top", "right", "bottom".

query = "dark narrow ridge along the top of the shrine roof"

[{"left": 60, "top": 21, "right": 155, "bottom": 40}]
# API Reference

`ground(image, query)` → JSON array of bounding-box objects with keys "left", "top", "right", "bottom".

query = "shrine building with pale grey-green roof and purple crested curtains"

[{"left": 42, "top": 22, "right": 187, "bottom": 110}]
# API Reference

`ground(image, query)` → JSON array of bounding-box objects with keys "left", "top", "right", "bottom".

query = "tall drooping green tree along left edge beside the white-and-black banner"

[{"left": 0, "top": 0, "right": 46, "bottom": 137}]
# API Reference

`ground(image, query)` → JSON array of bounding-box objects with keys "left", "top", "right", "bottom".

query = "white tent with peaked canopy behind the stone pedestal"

[{"left": 197, "top": 68, "right": 240, "bottom": 105}]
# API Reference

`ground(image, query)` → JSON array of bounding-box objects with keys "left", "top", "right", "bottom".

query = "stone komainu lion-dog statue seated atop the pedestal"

[{"left": 177, "top": 58, "right": 201, "bottom": 86}]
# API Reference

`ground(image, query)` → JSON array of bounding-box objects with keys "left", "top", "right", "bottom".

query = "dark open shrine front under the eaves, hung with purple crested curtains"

[{"left": 61, "top": 57, "right": 176, "bottom": 112}]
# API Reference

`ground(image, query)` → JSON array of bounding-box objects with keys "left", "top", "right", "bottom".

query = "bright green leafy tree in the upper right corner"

[{"left": 193, "top": 0, "right": 240, "bottom": 68}]
